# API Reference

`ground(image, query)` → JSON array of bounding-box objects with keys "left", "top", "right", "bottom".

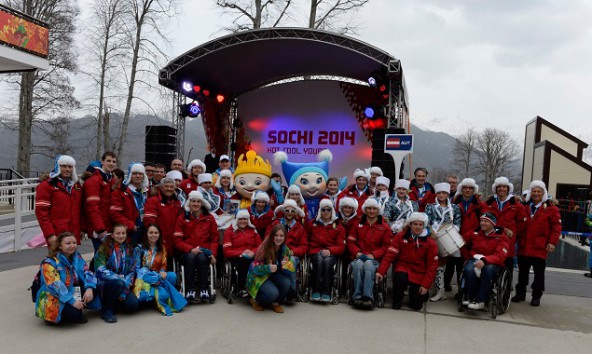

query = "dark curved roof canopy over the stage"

[{"left": 159, "top": 28, "right": 406, "bottom": 101}]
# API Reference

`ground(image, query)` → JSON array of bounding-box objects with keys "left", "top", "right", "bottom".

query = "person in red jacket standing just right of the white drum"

[{"left": 444, "top": 178, "right": 487, "bottom": 291}]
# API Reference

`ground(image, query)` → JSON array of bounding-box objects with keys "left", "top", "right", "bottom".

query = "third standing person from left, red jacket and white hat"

[{"left": 109, "top": 162, "right": 150, "bottom": 247}]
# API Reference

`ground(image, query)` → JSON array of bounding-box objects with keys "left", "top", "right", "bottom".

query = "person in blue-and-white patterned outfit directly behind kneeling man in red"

[{"left": 383, "top": 179, "right": 419, "bottom": 233}]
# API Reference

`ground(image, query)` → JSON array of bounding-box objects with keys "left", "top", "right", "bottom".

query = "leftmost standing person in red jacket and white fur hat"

[{"left": 35, "top": 155, "right": 82, "bottom": 248}]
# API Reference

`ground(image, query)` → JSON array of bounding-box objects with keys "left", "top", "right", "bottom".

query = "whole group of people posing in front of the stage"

[{"left": 35, "top": 152, "right": 561, "bottom": 324}]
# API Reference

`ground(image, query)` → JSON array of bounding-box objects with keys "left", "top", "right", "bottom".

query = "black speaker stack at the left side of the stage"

[{"left": 145, "top": 125, "right": 177, "bottom": 169}]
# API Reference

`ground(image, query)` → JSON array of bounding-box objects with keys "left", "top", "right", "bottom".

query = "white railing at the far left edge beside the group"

[{"left": 0, "top": 178, "right": 39, "bottom": 252}]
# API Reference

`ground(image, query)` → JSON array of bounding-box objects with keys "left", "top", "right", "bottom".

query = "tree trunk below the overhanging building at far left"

[{"left": 16, "top": 72, "right": 35, "bottom": 177}]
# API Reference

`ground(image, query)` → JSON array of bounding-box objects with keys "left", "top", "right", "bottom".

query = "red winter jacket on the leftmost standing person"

[{"left": 35, "top": 177, "right": 82, "bottom": 244}]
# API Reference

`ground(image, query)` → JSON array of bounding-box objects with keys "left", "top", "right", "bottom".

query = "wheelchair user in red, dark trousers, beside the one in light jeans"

[{"left": 307, "top": 199, "right": 345, "bottom": 302}]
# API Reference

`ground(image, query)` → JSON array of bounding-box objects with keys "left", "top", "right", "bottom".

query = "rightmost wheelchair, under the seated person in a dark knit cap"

[{"left": 456, "top": 267, "right": 512, "bottom": 319}]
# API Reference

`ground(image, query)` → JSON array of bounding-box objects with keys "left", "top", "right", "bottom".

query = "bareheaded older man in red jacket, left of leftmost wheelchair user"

[{"left": 143, "top": 177, "right": 181, "bottom": 270}]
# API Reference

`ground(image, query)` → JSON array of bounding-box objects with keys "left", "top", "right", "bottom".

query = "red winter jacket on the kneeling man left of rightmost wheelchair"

[{"left": 378, "top": 228, "right": 438, "bottom": 289}]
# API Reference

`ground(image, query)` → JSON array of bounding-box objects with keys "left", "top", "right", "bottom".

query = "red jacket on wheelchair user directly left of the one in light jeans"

[{"left": 306, "top": 220, "right": 345, "bottom": 256}]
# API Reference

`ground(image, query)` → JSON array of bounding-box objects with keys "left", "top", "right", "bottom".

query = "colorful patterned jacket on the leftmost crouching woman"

[{"left": 35, "top": 252, "right": 101, "bottom": 323}]
